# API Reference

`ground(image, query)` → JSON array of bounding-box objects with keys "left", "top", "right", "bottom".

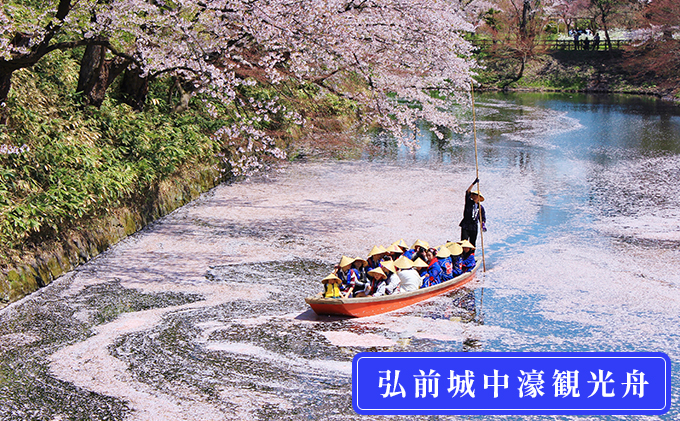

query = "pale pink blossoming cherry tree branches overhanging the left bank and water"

[{"left": 0, "top": 0, "right": 475, "bottom": 172}]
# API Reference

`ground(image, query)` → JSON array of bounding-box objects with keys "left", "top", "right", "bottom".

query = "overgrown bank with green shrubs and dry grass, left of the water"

[{"left": 0, "top": 51, "right": 357, "bottom": 305}]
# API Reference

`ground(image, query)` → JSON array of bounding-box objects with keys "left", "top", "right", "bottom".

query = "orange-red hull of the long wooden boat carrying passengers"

[{"left": 305, "top": 262, "right": 480, "bottom": 317}]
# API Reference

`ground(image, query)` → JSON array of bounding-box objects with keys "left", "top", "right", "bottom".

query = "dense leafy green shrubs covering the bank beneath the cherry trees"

[{"left": 0, "top": 52, "right": 220, "bottom": 254}]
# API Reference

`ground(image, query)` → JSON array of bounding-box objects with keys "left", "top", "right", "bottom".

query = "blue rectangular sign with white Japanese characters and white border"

[{"left": 352, "top": 352, "right": 671, "bottom": 415}]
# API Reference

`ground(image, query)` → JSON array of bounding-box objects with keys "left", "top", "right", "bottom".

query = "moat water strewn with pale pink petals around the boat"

[{"left": 0, "top": 94, "right": 680, "bottom": 420}]
